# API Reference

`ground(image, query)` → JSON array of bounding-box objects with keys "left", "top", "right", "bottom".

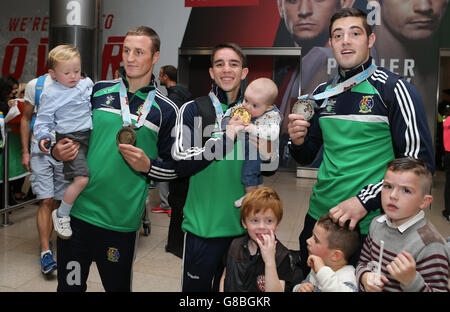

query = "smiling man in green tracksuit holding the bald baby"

[{"left": 173, "top": 43, "right": 248, "bottom": 291}]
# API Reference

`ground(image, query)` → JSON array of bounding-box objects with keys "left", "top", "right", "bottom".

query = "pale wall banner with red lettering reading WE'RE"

[{"left": 0, "top": 0, "right": 191, "bottom": 82}]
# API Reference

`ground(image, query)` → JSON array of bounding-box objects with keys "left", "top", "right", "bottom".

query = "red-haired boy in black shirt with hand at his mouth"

[{"left": 220, "top": 187, "right": 292, "bottom": 292}]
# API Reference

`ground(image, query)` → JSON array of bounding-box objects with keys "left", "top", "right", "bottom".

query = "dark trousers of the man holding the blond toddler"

[{"left": 57, "top": 217, "right": 137, "bottom": 292}]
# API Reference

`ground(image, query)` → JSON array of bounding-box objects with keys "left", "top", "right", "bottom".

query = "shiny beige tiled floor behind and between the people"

[{"left": 0, "top": 172, "right": 450, "bottom": 292}]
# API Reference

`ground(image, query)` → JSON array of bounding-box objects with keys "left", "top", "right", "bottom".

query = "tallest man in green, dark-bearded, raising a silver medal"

[{"left": 288, "top": 8, "right": 434, "bottom": 274}]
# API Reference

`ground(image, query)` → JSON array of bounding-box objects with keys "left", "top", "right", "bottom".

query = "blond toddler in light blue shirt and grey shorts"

[{"left": 34, "top": 45, "right": 93, "bottom": 239}]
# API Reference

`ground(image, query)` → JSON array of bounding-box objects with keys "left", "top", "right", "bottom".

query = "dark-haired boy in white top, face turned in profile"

[{"left": 293, "top": 214, "right": 360, "bottom": 292}]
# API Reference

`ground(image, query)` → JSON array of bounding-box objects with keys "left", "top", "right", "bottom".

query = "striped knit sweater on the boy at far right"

[{"left": 356, "top": 212, "right": 450, "bottom": 292}]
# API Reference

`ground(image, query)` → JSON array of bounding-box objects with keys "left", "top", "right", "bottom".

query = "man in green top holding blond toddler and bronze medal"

[{"left": 52, "top": 26, "right": 178, "bottom": 291}]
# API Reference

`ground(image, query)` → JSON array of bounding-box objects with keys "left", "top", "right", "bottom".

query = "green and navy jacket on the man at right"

[{"left": 289, "top": 58, "right": 434, "bottom": 234}]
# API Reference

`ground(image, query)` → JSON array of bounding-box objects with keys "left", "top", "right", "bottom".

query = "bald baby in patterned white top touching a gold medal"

[{"left": 224, "top": 78, "right": 281, "bottom": 207}]
